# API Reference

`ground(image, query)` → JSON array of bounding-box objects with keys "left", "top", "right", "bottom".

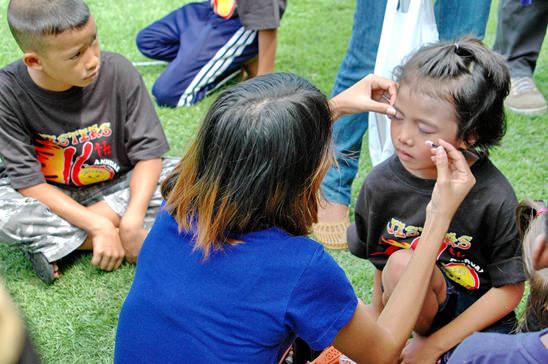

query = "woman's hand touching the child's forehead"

[{"left": 329, "top": 74, "right": 398, "bottom": 120}]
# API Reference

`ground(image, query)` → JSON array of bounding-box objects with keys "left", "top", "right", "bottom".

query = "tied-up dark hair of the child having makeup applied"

[{"left": 395, "top": 37, "right": 510, "bottom": 155}]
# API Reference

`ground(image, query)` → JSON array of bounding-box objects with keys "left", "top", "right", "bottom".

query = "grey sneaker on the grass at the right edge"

[{"left": 506, "top": 77, "right": 548, "bottom": 115}]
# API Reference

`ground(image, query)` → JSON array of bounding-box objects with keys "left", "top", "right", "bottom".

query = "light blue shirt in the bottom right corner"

[{"left": 448, "top": 329, "right": 548, "bottom": 364}]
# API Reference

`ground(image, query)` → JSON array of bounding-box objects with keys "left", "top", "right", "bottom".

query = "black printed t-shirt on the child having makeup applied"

[{"left": 348, "top": 156, "right": 525, "bottom": 292}]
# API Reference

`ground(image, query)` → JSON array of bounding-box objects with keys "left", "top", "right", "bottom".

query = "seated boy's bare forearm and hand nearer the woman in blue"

[{"left": 120, "top": 158, "right": 162, "bottom": 263}]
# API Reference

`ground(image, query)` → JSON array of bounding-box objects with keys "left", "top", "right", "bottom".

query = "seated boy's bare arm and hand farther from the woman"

[{"left": 19, "top": 183, "right": 124, "bottom": 271}]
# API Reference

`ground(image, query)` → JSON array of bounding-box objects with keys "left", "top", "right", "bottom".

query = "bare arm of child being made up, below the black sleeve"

[{"left": 402, "top": 283, "right": 524, "bottom": 363}]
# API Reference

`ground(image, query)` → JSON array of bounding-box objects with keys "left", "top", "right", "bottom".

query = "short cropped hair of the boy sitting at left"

[{"left": 8, "top": 0, "right": 90, "bottom": 52}]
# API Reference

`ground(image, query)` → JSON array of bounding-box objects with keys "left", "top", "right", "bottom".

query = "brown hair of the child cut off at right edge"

[{"left": 516, "top": 201, "right": 548, "bottom": 332}]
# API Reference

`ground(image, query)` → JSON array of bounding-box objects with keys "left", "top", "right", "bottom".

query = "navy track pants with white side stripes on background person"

[{"left": 137, "top": 1, "right": 258, "bottom": 107}]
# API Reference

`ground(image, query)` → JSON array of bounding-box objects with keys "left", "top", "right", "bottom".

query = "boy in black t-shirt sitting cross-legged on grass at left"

[{"left": 0, "top": 0, "right": 174, "bottom": 283}]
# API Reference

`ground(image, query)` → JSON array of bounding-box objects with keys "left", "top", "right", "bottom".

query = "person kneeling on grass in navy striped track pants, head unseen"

[{"left": 136, "top": 0, "right": 286, "bottom": 107}]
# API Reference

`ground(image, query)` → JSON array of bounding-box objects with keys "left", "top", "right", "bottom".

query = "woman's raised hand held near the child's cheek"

[{"left": 426, "top": 139, "right": 476, "bottom": 218}]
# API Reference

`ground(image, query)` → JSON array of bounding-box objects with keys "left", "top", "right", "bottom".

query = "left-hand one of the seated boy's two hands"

[{"left": 89, "top": 217, "right": 125, "bottom": 271}]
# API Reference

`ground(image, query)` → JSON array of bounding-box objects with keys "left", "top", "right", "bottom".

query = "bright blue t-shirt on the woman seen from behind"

[{"left": 114, "top": 210, "right": 357, "bottom": 364}]
